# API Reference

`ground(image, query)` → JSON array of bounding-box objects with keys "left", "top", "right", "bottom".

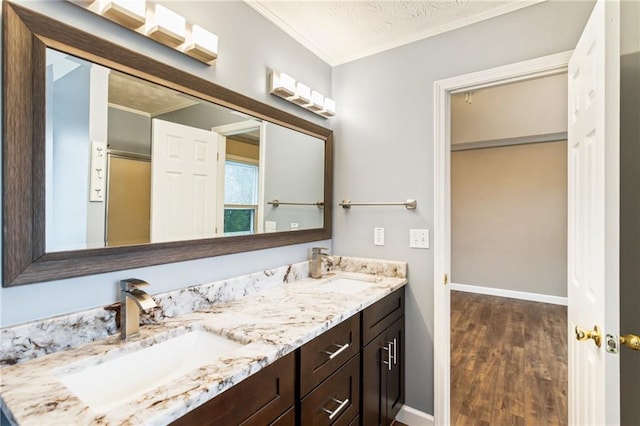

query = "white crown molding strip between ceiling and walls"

[{"left": 244, "top": 0, "right": 545, "bottom": 67}]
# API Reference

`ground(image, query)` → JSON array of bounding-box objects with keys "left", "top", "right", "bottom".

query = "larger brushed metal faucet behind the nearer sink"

[{"left": 120, "top": 278, "right": 157, "bottom": 339}]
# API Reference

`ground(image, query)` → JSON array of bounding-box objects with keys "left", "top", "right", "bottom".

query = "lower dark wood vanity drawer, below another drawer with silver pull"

[{"left": 301, "top": 355, "right": 360, "bottom": 425}]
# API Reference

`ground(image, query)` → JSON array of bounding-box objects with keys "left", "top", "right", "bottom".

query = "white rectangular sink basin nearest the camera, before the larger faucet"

[{"left": 58, "top": 330, "right": 244, "bottom": 413}]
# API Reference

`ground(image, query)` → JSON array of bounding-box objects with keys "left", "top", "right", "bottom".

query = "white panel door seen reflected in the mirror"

[{"left": 151, "top": 119, "right": 218, "bottom": 242}]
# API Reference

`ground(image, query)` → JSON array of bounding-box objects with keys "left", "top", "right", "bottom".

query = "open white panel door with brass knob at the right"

[{"left": 568, "top": 0, "right": 620, "bottom": 425}]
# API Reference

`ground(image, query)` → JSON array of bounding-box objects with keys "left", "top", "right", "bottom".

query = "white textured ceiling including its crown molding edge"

[{"left": 245, "top": 0, "right": 544, "bottom": 65}]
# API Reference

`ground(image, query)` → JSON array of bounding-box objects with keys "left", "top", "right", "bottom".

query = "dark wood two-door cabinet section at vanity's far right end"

[{"left": 360, "top": 289, "right": 405, "bottom": 426}]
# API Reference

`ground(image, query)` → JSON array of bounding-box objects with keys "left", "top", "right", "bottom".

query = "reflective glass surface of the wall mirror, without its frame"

[{"left": 45, "top": 48, "right": 325, "bottom": 252}]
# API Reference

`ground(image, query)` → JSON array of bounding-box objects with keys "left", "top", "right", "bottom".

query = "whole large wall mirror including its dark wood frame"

[{"left": 3, "top": 2, "right": 333, "bottom": 286}]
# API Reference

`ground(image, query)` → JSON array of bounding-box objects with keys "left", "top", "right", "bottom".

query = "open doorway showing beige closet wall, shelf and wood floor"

[{"left": 450, "top": 73, "right": 568, "bottom": 425}]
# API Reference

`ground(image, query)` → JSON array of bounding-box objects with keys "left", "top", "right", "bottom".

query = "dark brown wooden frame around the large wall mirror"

[{"left": 2, "top": 2, "right": 333, "bottom": 287}]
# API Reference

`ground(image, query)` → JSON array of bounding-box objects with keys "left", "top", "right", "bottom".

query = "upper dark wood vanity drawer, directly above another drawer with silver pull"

[{"left": 300, "top": 315, "right": 360, "bottom": 396}]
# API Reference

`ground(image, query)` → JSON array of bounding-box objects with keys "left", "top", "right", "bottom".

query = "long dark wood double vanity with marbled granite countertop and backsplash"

[{"left": 0, "top": 256, "right": 407, "bottom": 425}]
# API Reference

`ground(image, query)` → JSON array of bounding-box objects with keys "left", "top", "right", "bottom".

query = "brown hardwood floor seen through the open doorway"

[{"left": 451, "top": 291, "right": 567, "bottom": 426}]
